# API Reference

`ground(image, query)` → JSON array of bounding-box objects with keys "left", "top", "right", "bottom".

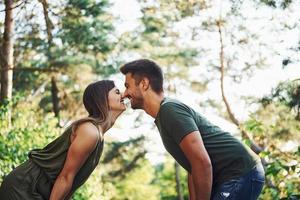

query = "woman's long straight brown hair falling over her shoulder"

[{"left": 71, "top": 80, "right": 115, "bottom": 139}]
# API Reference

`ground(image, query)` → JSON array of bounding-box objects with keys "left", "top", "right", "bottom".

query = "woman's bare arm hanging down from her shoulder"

[{"left": 50, "top": 123, "right": 99, "bottom": 200}]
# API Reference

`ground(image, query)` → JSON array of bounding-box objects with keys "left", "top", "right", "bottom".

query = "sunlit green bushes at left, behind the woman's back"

[{"left": 0, "top": 99, "right": 60, "bottom": 182}]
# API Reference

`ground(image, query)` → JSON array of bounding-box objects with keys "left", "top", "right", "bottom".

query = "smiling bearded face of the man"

[{"left": 123, "top": 73, "right": 144, "bottom": 109}]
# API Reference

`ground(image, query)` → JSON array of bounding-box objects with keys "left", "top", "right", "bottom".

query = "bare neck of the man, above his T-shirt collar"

[{"left": 143, "top": 92, "right": 164, "bottom": 118}]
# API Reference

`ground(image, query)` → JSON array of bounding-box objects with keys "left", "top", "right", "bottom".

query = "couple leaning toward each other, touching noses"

[{"left": 0, "top": 59, "right": 264, "bottom": 200}]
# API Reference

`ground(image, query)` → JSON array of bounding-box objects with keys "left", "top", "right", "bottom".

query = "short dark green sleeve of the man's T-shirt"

[{"left": 159, "top": 102, "right": 198, "bottom": 144}]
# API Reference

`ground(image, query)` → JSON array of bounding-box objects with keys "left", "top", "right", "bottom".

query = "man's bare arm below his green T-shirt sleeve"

[{"left": 179, "top": 131, "right": 212, "bottom": 200}]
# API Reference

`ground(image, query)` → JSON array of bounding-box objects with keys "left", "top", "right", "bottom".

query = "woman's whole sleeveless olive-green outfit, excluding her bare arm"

[{"left": 0, "top": 121, "right": 103, "bottom": 200}]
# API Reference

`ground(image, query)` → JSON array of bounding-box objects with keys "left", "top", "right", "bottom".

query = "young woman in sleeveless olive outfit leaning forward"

[{"left": 0, "top": 80, "right": 125, "bottom": 200}]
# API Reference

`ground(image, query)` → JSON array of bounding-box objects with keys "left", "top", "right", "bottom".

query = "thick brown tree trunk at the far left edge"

[{"left": 0, "top": 0, "right": 14, "bottom": 127}]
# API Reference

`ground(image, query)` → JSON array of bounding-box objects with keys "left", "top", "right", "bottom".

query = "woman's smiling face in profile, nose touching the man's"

[{"left": 108, "top": 87, "right": 126, "bottom": 111}]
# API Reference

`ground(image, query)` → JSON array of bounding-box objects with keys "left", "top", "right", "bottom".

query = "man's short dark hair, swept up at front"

[{"left": 120, "top": 59, "right": 163, "bottom": 93}]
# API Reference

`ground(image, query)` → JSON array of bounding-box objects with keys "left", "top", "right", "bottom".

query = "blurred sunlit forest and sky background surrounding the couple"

[{"left": 0, "top": 0, "right": 300, "bottom": 200}]
